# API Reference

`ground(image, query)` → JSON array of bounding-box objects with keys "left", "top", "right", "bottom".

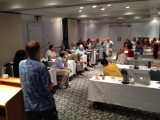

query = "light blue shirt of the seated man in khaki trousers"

[{"left": 52, "top": 57, "right": 65, "bottom": 69}]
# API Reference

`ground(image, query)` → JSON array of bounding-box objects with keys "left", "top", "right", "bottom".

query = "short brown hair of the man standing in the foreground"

[{"left": 26, "top": 41, "right": 40, "bottom": 58}]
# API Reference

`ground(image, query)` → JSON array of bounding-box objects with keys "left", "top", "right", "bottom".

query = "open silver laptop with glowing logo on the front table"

[{"left": 134, "top": 72, "right": 150, "bottom": 85}]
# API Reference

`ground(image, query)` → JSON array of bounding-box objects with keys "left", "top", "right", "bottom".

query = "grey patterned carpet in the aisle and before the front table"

[{"left": 55, "top": 65, "right": 160, "bottom": 120}]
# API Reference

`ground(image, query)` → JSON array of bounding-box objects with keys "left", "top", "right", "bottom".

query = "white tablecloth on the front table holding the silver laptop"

[{"left": 88, "top": 76, "right": 160, "bottom": 113}]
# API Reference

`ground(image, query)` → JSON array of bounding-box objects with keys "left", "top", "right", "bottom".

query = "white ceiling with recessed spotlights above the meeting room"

[{"left": 0, "top": 0, "right": 160, "bottom": 20}]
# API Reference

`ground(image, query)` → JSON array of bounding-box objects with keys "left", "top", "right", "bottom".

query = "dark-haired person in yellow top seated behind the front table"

[{"left": 101, "top": 59, "right": 122, "bottom": 77}]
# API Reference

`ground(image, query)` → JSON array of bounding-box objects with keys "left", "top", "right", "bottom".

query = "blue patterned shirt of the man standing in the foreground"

[{"left": 19, "top": 58, "right": 55, "bottom": 111}]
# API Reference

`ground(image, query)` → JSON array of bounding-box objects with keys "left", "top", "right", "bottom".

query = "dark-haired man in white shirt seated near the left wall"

[{"left": 45, "top": 45, "right": 57, "bottom": 60}]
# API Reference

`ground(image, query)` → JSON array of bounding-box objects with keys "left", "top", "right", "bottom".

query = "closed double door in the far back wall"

[{"left": 109, "top": 25, "right": 131, "bottom": 51}]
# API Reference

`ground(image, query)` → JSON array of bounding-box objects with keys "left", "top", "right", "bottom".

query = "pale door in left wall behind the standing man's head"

[{"left": 28, "top": 23, "right": 45, "bottom": 57}]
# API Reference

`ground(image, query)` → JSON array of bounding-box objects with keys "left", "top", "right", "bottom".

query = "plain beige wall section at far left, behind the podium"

[{"left": 0, "top": 13, "right": 23, "bottom": 76}]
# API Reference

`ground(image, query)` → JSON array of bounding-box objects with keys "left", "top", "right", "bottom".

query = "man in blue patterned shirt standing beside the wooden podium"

[{"left": 19, "top": 41, "right": 58, "bottom": 120}]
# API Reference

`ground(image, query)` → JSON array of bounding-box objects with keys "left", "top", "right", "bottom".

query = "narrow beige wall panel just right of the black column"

[{"left": 68, "top": 19, "right": 78, "bottom": 46}]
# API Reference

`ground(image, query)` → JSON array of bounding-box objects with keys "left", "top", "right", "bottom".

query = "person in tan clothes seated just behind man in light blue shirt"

[{"left": 69, "top": 52, "right": 86, "bottom": 75}]
